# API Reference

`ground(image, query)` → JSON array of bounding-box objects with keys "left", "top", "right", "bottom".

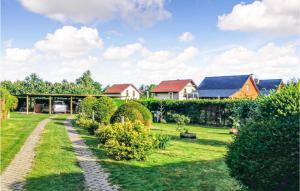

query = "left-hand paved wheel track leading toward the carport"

[{"left": 0, "top": 118, "right": 50, "bottom": 191}]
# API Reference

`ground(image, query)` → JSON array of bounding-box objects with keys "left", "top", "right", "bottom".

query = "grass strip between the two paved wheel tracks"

[{"left": 26, "top": 115, "right": 84, "bottom": 191}]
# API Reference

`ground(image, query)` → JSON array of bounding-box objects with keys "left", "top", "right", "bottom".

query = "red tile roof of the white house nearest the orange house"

[{"left": 152, "top": 79, "right": 196, "bottom": 93}]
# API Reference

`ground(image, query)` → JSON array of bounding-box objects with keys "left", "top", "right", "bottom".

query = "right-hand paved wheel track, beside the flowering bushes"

[{"left": 65, "top": 118, "right": 119, "bottom": 191}]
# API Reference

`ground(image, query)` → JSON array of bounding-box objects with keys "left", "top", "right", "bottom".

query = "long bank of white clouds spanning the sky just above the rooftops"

[{"left": 0, "top": 24, "right": 300, "bottom": 85}]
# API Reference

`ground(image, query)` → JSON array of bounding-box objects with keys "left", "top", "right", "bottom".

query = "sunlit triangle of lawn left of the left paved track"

[{"left": 0, "top": 112, "right": 49, "bottom": 172}]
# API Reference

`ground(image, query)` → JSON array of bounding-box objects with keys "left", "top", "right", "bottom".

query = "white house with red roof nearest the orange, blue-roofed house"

[{"left": 152, "top": 79, "right": 197, "bottom": 100}]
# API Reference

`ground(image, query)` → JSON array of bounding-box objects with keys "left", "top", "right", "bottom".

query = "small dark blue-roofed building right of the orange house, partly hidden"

[{"left": 256, "top": 79, "right": 284, "bottom": 95}]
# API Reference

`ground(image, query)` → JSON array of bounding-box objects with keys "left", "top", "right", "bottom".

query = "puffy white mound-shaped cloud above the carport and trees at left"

[{"left": 34, "top": 26, "right": 103, "bottom": 57}]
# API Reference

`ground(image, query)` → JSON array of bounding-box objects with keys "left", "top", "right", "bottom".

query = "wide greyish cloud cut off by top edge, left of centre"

[{"left": 20, "top": 0, "right": 171, "bottom": 26}]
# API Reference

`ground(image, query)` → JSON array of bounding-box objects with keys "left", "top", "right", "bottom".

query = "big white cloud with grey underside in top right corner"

[{"left": 218, "top": 0, "right": 300, "bottom": 35}]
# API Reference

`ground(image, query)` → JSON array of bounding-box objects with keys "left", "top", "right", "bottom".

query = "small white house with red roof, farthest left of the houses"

[{"left": 104, "top": 84, "right": 141, "bottom": 99}]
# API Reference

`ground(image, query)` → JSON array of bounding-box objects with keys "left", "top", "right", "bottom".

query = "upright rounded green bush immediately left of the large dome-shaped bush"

[{"left": 93, "top": 96, "right": 117, "bottom": 125}]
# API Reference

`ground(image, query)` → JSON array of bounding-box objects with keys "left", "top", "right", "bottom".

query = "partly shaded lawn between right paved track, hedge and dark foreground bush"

[{"left": 77, "top": 124, "right": 240, "bottom": 191}]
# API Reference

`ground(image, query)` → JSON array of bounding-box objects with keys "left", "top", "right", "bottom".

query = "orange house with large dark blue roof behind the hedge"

[{"left": 198, "top": 75, "right": 259, "bottom": 99}]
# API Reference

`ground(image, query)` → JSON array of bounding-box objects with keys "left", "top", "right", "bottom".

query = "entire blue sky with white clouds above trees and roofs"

[{"left": 0, "top": 0, "right": 300, "bottom": 86}]
